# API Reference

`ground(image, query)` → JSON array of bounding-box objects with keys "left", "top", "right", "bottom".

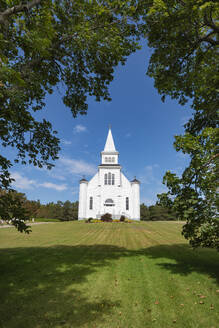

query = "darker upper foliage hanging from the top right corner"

[{"left": 144, "top": 0, "right": 219, "bottom": 134}]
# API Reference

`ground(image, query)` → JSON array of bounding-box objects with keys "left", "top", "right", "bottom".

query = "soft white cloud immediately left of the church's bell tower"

[{"left": 59, "top": 157, "right": 97, "bottom": 175}]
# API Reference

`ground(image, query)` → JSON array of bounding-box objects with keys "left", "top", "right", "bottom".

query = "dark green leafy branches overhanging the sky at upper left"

[{"left": 0, "top": 0, "right": 139, "bottom": 231}]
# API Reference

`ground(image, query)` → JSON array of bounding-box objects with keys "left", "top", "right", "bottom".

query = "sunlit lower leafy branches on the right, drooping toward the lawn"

[{"left": 158, "top": 128, "right": 219, "bottom": 250}]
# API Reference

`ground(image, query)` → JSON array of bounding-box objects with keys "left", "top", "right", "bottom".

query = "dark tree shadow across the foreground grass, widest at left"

[{"left": 0, "top": 244, "right": 219, "bottom": 328}]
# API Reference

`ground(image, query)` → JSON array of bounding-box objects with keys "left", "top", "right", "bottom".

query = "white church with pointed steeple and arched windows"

[{"left": 78, "top": 128, "right": 140, "bottom": 220}]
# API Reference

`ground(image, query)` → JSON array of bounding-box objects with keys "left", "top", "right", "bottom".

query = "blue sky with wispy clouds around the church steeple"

[{"left": 3, "top": 47, "right": 191, "bottom": 205}]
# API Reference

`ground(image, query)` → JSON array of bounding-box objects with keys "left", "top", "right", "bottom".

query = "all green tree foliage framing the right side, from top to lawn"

[{"left": 141, "top": 0, "right": 219, "bottom": 248}]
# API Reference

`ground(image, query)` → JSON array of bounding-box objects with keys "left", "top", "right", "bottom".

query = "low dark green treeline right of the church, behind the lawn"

[{"left": 140, "top": 203, "right": 176, "bottom": 221}]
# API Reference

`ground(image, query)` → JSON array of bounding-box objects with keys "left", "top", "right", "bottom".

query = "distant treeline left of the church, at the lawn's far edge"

[{"left": 0, "top": 190, "right": 78, "bottom": 221}]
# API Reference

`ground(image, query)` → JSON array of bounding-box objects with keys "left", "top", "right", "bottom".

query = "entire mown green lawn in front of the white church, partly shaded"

[{"left": 0, "top": 222, "right": 219, "bottom": 328}]
